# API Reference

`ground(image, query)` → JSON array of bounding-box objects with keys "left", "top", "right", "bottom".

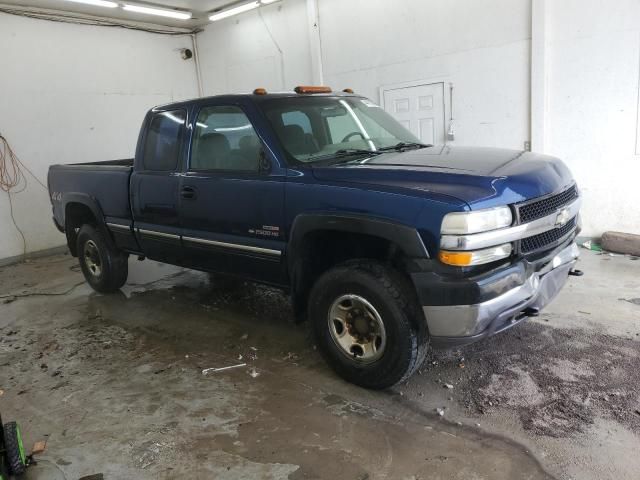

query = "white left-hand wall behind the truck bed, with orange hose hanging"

[{"left": 0, "top": 14, "right": 197, "bottom": 259}]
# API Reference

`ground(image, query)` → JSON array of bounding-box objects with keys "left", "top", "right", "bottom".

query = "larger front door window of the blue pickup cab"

[{"left": 190, "top": 106, "right": 261, "bottom": 171}]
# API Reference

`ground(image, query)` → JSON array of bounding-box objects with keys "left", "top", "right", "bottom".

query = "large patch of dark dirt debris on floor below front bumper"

[{"left": 423, "top": 322, "right": 640, "bottom": 438}]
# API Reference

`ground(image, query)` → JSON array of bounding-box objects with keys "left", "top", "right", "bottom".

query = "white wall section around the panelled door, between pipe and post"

[{"left": 319, "top": 0, "right": 531, "bottom": 148}]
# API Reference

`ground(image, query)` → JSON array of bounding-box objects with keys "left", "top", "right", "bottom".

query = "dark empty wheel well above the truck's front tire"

[{"left": 291, "top": 230, "right": 406, "bottom": 318}]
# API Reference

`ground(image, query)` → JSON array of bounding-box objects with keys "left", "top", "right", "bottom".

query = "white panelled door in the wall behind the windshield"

[{"left": 383, "top": 83, "right": 445, "bottom": 145}]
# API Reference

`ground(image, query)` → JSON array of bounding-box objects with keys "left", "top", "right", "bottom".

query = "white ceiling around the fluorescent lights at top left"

[{"left": 0, "top": 0, "right": 245, "bottom": 28}]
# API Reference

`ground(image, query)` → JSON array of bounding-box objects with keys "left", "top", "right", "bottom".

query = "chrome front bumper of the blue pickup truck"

[{"left": 423, "top": 243, "right": 580, "bottom": 345}]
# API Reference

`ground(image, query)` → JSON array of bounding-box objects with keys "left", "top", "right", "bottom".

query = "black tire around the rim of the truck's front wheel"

[{"left": 309, "top": 260, "right": 429, "bottom": 389}]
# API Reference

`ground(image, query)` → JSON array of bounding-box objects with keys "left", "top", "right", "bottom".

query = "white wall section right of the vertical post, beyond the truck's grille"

[{"left": 546, "top": 0, "right": 640, "bottom": 236}]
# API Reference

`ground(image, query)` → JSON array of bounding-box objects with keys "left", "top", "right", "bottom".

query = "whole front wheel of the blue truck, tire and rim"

[{"left": 309, "top": 260, "right": 428, "bottom": 389}]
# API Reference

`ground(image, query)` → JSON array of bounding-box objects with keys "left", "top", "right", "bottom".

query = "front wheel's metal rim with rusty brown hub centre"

[{"left": 328, "top": 294, "right": 387, "bottom": 363}]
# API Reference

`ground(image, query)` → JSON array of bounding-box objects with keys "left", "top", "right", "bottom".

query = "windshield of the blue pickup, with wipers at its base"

[{"left": 262, "top": 97, "right": 428, "bottom": 163}]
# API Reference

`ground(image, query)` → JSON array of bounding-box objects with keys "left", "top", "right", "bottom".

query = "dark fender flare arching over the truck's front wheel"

[{"left": 287, "top": 213, "right": 429, "bottom": 273}]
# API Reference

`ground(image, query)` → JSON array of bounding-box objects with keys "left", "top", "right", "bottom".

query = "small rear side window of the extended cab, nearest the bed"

[{"left": 142, "top": 110, "right": 187, "bottom": 172}]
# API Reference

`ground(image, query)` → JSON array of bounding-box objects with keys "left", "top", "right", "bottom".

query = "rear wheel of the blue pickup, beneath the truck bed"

[{"left": 77, "top": 225, "right": 129, "bottom": 293}]
